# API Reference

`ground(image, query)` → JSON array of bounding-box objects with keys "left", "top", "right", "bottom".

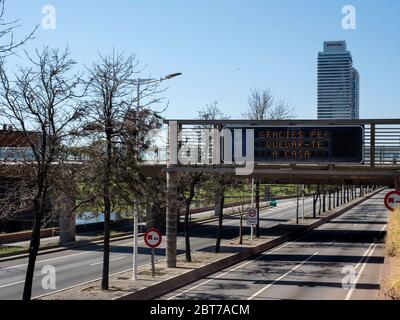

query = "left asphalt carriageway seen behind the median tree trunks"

[{"left": 0, "top": 198, "right": 312, "bottom": 300}]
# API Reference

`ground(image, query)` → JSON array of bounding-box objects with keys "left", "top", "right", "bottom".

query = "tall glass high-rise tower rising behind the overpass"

[{"left": 317, "top": 41, "right": 360, "bottom": 119}]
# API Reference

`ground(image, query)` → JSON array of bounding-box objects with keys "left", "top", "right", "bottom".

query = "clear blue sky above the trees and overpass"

[{"left": 6, "top": 0, "right": 400, "bottom": 118}]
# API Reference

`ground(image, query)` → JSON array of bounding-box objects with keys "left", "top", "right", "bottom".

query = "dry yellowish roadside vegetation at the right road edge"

[{"left": 385, "top": 209, "right": 400, "bottom": 300}]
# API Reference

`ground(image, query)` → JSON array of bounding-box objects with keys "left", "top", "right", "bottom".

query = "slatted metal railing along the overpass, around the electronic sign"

[{"left": 158, "top": 119, "right": 400, "bottom": 168}]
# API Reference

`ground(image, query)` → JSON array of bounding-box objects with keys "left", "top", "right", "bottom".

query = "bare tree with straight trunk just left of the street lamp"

[{"left": 83, "top": 52, "right": 160, "bottom": 290}]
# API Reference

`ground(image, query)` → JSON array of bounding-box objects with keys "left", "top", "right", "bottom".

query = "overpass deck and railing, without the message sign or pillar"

[{"left": 161, "top": 119, "right": 400, "bottom": 185}]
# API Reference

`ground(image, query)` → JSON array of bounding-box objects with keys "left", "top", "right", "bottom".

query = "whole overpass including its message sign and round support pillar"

[{"left": 162, "top": 119, "right": 400, "bottom": 267}]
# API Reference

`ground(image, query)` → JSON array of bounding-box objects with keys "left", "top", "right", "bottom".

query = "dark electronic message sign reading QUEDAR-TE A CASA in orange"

[{"left": 225, "top": 126, "right": 364, "bottom": 163}]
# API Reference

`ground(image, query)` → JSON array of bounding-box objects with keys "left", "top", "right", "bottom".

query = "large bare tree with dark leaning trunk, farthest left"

[{"left": 0, "top": 48, "right": 82, "bottom": 300}]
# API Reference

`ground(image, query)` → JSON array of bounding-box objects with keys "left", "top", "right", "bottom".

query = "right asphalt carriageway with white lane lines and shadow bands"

[{"left": 161, "top": 191, "right": 388, "bottom": 301}]
